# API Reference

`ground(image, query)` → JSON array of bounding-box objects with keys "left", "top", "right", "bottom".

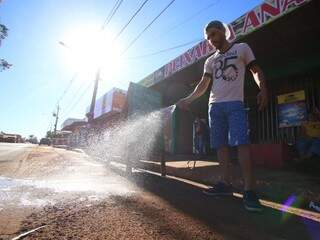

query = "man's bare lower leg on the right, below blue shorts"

[{"left": 238, "top": 144, "right": 255, "bottom": 191}]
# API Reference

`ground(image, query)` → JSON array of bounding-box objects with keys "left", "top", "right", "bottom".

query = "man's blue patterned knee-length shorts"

[{"left": 209, "top": 101, "right": 250, "bottom": 149}]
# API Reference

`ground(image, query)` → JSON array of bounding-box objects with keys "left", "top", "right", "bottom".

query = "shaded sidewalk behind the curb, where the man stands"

[{"left": 139, "top": 160, "right": 320, "bottom": 213}]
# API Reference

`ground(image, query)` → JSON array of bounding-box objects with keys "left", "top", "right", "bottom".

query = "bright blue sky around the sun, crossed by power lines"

[{"left": 0, "top": 0, "right": 262, "bottom": 138}]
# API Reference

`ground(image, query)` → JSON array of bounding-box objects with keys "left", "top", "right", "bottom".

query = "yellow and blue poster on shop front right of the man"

[{"left": 277, "top": 91, "right": 307, "bottom": 128}]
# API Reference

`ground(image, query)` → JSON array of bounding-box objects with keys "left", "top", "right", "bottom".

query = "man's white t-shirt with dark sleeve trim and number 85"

[{"left": 204, "top": 43, "right": 255, "bottom": 104}]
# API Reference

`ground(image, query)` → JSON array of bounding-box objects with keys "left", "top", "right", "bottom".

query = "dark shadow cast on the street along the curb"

[{"left": 112, "top": 164, "right": 320, "bottom": 240}]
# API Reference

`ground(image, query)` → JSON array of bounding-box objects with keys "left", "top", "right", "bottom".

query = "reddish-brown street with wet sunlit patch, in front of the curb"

[{"left": 0, "top": 143, "right": 320, "bottom": 240}]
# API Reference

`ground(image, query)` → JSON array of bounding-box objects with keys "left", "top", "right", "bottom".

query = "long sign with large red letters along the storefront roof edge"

[{"left": 140, "top": 0, "right": 311, "bottom": 87}]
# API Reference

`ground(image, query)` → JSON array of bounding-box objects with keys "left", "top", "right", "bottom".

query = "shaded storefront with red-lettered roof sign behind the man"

[{"left": 140, "top": 0, "right": 320, "bottom": 161}]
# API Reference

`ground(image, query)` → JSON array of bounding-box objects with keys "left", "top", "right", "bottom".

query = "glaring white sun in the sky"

[{"left": 59, "top": 25, "right": 121, "bottom": 79}]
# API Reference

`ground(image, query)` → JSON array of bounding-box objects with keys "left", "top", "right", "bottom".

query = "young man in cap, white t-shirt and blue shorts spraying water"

[{"left": 177, "top": 21, "right": 268, "bottom": 211}]
